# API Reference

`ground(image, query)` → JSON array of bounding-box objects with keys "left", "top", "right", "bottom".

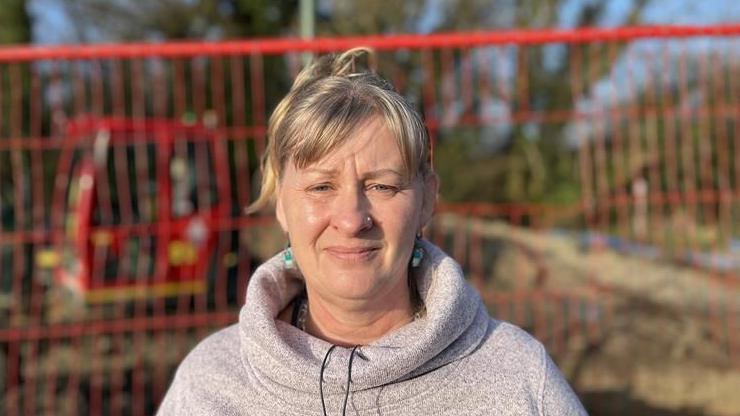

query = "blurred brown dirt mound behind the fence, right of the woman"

[{"left": 434, "top": 215, "right": 740, "bottom": 416}]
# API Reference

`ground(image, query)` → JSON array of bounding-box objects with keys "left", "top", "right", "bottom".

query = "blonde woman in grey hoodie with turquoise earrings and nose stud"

[{"left": 159, "top": 49, "right": 585, "bottom": 415}]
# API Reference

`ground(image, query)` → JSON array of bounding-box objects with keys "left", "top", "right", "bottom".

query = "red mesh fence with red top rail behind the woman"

[{"left": 0, "top": 25, "right": 740, "bottom": 415}]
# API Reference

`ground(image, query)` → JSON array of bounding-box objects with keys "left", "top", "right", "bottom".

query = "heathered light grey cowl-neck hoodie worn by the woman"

[{"left": 158, "top": 242, "right": 586, "bottom": 416}]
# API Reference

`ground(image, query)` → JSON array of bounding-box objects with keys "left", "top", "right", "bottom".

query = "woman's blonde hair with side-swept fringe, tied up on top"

[{"left": 247, "top": 48, "right": 431, "bottom": 213}]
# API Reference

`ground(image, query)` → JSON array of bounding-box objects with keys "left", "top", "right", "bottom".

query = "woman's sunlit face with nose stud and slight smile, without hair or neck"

[{"left": 276, "top": 118, "right": 437, "bottom": 306}]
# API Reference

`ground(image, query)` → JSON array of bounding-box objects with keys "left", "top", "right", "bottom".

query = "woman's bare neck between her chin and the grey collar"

[{"left": 305, "top": 281, "right": 414, "bottom": 347}]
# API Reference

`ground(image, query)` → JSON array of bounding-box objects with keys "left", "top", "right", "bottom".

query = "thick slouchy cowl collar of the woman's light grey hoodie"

[{"left": 238, "top": 241, "right": 490, "bottom": 404}]
